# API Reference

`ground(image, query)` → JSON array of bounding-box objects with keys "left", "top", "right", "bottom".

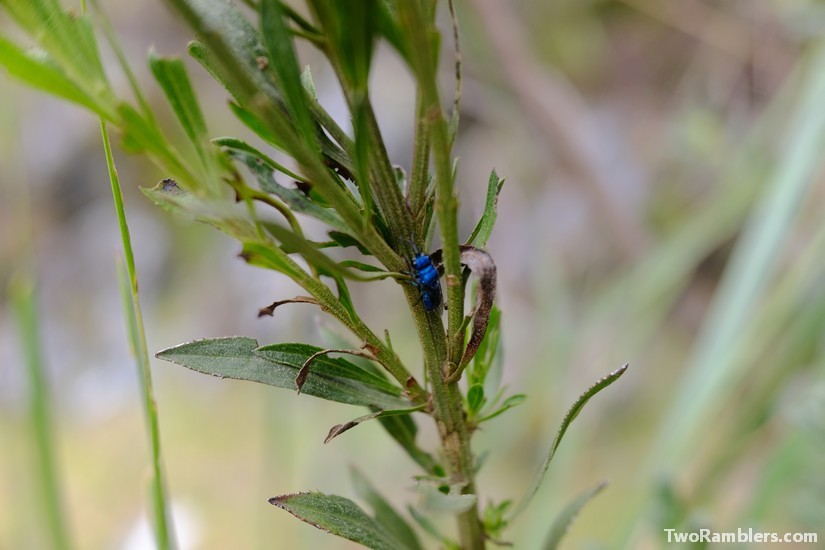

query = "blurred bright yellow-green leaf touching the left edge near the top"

[{"left": 0, "top": 37, "right": 109, "bottom": 121}]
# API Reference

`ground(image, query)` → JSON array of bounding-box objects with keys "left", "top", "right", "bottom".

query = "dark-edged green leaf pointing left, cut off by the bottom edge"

[{"left": 269, "top": 492, "right": 409, "bottom": 550}]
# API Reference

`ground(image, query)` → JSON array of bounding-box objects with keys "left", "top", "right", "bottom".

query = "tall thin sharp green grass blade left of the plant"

[{"left": 100, "top": 120, "right": 177, "bottom": 550}]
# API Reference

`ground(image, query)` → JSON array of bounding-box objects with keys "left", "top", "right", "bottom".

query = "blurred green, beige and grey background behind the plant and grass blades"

[{"left": 0, "top": 0, "right": 825, "bottom": 550}]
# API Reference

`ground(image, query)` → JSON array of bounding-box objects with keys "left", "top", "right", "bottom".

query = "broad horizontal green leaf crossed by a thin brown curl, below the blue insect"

[{"left": 156, "top": 336, "right": 410, "bottom": 409}]
